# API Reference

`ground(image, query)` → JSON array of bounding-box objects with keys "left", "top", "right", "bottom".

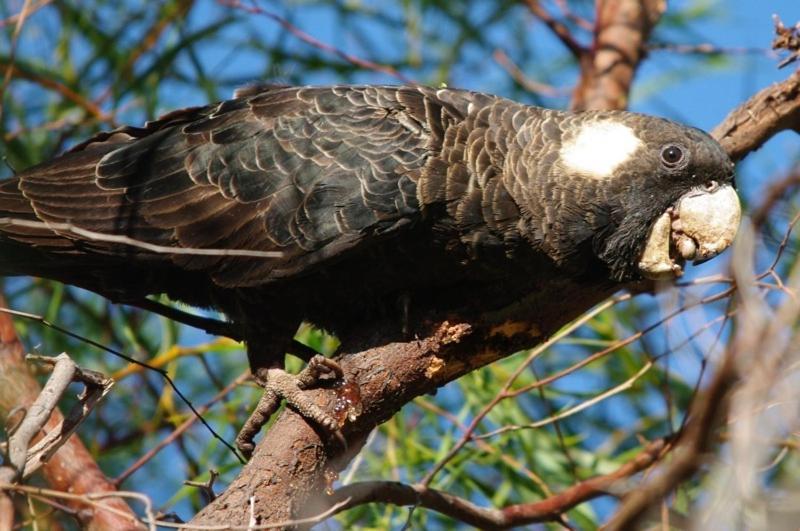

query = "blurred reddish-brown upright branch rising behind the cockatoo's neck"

[{"left": 570, "top": 0, "right": 667, "bottom": 110}]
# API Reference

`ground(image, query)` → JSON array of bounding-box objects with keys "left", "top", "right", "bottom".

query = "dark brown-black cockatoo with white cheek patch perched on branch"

[{"left": 0, "top": 86, "right": 740, "bottom": 456}]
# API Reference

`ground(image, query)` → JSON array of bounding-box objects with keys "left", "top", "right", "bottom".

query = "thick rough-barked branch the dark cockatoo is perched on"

[{"left": 191, "top": 285, "right": 616, "bottom": 525}]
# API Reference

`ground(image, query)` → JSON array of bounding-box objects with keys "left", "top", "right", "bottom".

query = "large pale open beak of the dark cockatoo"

[{"left": 639, "top": 185, "right": 742, "bottom": 279}]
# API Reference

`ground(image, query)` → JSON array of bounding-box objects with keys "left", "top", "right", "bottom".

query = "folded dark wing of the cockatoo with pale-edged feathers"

[{"left": 0, "top": 87, "right": 459, "bottom": 288}]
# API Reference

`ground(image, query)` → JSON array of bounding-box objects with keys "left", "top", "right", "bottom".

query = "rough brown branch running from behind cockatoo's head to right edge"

[{"left": 711, "top": 71, "right": 800, "bottom": 161}]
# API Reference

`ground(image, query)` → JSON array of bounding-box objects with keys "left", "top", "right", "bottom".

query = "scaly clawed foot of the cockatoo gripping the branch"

[{"left": 236, "top": 355, "right": 360, "bottom": 457}]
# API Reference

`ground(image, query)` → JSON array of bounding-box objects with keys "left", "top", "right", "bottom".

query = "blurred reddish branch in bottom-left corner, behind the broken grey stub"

[{"left": 0, "top": 299, "right": 140, "bottom": 530}]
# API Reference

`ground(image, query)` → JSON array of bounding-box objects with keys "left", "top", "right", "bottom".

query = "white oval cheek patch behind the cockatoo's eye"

[{"left": 559, "top": 121, "right": 642, "bottom": 179}]
